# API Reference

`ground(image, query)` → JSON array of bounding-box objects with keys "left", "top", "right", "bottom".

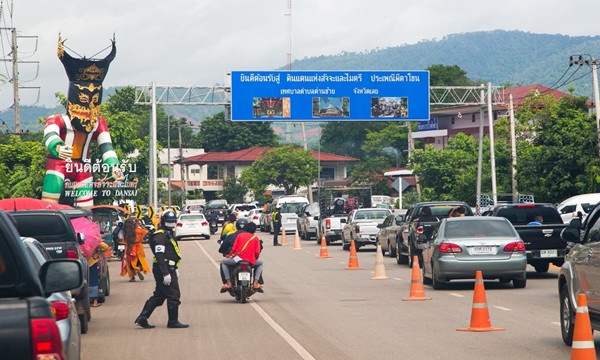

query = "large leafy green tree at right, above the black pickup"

[{"left": 497, "top": 94, "right": 600, "bottom": 203}]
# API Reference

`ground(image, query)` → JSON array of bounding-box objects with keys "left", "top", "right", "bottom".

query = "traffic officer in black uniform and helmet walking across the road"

[{"left": 135, "top": 210, "right": 189, "bottom": 329}]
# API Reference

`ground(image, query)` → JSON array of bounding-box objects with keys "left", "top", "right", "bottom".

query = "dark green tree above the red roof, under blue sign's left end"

[{"left": 197, "top": 112, "right": 278, "bottom": 152}]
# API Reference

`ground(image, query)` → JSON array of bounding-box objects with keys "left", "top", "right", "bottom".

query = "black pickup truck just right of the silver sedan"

[{"left": 482, "top": 203, "right": 568, "bottom": 273}]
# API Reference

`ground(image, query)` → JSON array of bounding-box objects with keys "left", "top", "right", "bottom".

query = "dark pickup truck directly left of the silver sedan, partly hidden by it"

[{"left": 396, "top": 201, "right": 473, "bottom": 267}]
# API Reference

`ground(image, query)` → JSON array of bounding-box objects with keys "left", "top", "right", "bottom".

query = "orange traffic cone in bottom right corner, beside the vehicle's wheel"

[{"left": 571, "top": 294, "right": 596, "bottom": 360}]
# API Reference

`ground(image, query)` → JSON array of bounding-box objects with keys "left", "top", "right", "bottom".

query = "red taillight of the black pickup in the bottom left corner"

[{"left": 31, "top": 319, "right": 65, "bottom": 360}]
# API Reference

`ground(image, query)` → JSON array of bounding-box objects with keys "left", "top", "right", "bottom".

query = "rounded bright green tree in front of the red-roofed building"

[{"left": 240, "top": 145, "right": 318, "bottom": 195}]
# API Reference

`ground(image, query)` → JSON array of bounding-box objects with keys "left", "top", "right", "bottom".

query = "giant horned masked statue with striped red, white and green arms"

[{"left": 42, "top": 34, "right": 123, "bottom": 207}]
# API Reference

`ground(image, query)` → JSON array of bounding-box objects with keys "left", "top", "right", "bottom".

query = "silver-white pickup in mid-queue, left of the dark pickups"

[{"left": 342, "top": 208, "right": 392, "bottom": 250}]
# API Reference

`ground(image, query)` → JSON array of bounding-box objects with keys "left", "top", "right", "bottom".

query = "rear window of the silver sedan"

[{"left": 444, "top": 219, "right": 516, "bottom": 238}]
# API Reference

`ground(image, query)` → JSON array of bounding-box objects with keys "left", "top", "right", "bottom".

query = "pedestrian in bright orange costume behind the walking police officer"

[{"left": 121, "top": 217, "right": 150, "bottom": 281}]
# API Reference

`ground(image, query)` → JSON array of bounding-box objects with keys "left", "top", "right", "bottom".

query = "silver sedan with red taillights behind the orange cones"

[{"left": 423, "top": 216, "right": 527, "bottom": 289}]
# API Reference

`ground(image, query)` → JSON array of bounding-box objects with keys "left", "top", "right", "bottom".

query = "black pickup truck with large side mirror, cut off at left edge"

[{"left": 0, "top": 211, "right": 84, "bottom": 360}]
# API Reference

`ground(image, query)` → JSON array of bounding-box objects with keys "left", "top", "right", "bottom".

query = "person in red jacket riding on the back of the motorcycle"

[{"left": 221, "top": 219, "right": 263, "bottom": 292}]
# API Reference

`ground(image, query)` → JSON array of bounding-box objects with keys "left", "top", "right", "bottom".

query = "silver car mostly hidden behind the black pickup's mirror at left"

[{"left": 21, "top": 237, "right": 81, "bottom": 360}]
